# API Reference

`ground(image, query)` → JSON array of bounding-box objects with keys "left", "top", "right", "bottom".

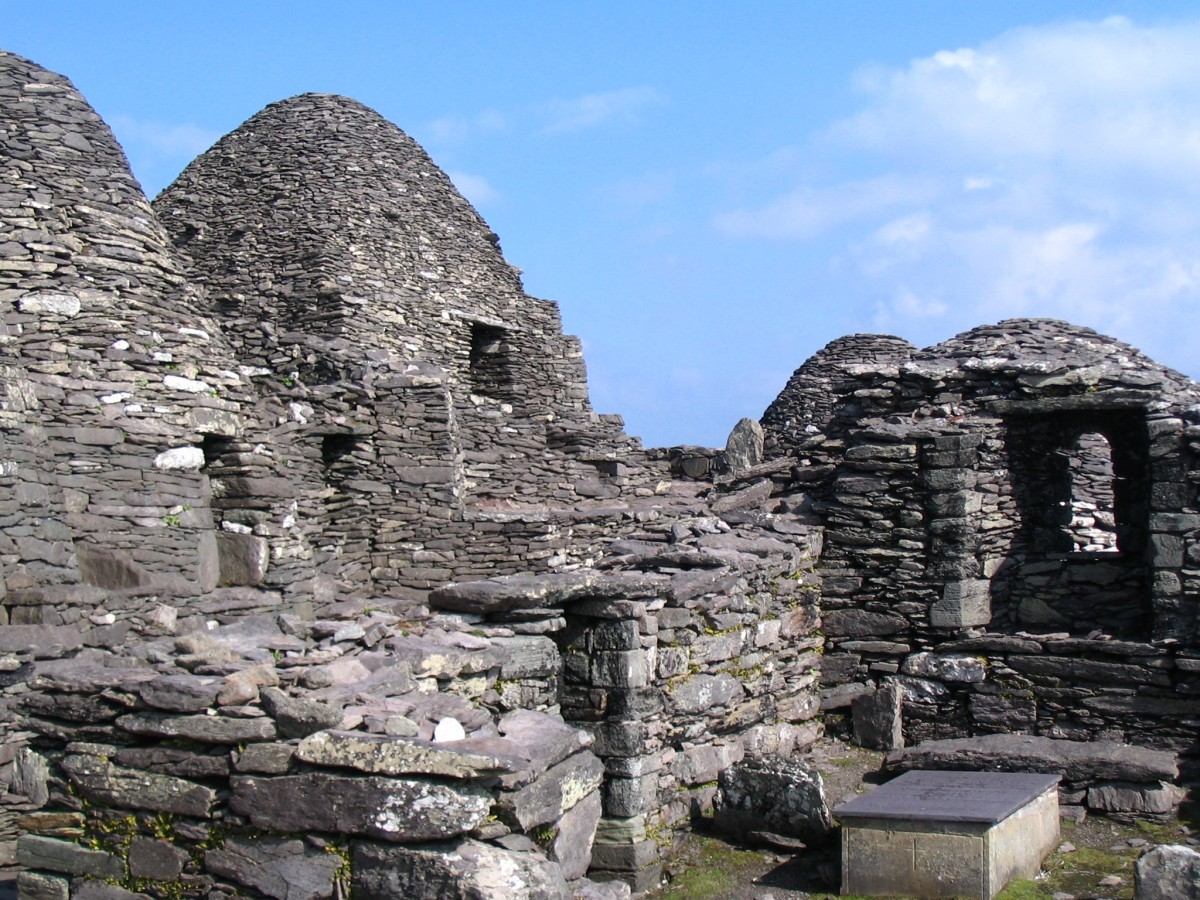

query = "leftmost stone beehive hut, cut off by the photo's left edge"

[{"left": 0, "top": 54, "right": 259, "bottom": 623}]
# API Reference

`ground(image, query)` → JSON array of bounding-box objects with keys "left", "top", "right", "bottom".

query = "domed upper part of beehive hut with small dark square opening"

[{"left": 155, "top": 94, "right": 589, "bottom": 415}]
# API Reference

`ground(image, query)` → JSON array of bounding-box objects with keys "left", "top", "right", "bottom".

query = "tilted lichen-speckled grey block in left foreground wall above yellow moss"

[{"left": 62, "top": 755, "right": 217, "bottom": 818}]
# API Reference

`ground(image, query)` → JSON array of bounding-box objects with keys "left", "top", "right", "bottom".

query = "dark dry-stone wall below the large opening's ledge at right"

[{"left": 822, "top": 633, "right": 1200, "bottom": 770}]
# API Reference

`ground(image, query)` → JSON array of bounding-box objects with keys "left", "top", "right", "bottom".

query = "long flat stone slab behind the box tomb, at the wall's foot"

[{"left": 884, "top": 734, "right": 1178, "bottom": 784}]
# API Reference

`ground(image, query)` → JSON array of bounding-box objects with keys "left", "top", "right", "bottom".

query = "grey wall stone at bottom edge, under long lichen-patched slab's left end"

[{"left": 204, "top": 838, "right": 342, "bottom": 900}]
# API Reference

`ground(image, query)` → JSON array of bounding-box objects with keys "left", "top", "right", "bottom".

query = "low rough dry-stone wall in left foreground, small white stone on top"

[{"left": 0, "top": 606, "right": 628, "bottom": 900}]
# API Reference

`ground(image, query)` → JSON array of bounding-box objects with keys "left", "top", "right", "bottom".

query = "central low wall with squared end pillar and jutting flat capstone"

[{"left": 431, "top": 512, "right": 822, "bottom": 890}]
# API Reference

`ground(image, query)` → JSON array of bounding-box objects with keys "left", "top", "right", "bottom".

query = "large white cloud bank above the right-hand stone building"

[{"left": 714, "top": 18, "right": 1200, "bottom": 370}]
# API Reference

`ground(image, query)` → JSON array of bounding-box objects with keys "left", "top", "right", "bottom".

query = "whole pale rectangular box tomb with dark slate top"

[{"left": 834, "top": 770, "right": 1058, "bottom": 900}]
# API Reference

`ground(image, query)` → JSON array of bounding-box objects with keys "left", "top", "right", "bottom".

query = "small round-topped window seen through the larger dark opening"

[{"left": 1061, "top": 431, "right": 1120, "bottom": 553}]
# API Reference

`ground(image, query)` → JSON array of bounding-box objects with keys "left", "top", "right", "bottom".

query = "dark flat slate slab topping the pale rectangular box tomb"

[{"left": 834, "top": 770, "right": 1058, "bottom": 824}]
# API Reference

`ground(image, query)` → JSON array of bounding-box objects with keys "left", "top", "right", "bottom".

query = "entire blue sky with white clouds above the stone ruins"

[{"left": 9, "top": 0, "right": 1200, "bottom": 445}]
